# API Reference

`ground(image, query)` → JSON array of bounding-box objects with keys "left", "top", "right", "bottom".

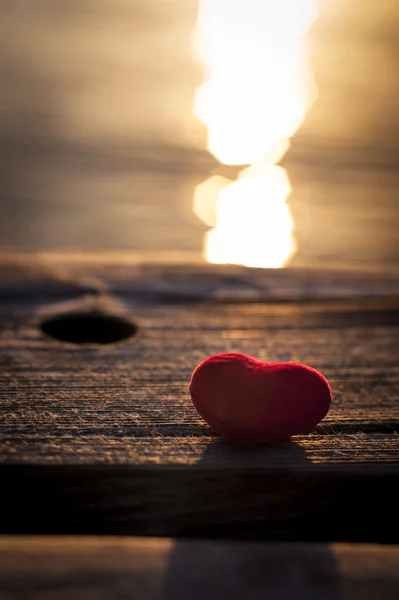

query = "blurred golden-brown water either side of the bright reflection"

[{"left": 0, "top": 0, "right": 399, "bottom": 264}]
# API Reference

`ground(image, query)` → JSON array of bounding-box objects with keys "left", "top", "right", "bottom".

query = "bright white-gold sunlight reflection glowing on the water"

[{"left": 194, "top": 0, "right": 316, "bottom": 267}]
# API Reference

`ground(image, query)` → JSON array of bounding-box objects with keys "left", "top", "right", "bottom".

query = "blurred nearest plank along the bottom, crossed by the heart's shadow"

[{"left": 0, "top": 537, "right": 399, "bottom": 600}]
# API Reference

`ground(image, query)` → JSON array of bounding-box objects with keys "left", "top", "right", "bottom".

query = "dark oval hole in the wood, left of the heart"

[{"left": 41, "top": 313, "right": 137, "bottom": 344}]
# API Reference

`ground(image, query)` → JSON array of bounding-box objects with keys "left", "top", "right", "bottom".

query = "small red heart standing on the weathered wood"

[{"left": 190, "top": 353, "right": 331, "bottom": 444}]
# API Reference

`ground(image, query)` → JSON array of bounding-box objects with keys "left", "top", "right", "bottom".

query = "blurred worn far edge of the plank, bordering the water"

[{"left": 0, "top": 252, "right": 399, "bottom": 303}]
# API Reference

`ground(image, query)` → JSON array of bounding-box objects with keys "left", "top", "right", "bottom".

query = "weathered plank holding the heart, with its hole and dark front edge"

[{"left": 0, "top": 261, "right": 399, "bottom": 542}]
